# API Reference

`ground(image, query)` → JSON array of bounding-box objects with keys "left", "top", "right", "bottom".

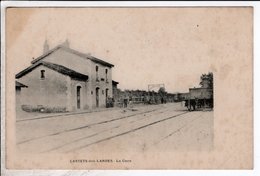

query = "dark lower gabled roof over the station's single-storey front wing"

[{"left": 15, "top": 61, "right": 88, "bottom": 80}]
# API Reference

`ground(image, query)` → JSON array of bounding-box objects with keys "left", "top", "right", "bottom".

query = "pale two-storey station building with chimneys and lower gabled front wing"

[{"left": 16, "top": 41, "right": 118, "bottom": 111}]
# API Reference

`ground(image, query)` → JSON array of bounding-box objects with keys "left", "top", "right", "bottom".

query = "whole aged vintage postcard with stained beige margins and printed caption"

[{"left": 5, "top": 7, "right": 253, "bottom": 170}]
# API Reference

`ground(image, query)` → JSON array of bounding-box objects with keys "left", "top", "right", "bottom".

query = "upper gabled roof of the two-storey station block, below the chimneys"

[{"left": 31, "top": 45, "right": 114, "bottom": 67}]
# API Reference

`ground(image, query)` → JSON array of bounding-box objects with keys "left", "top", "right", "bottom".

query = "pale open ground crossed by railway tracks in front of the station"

[{"left": 16, "top": 103, "right": 213, "bottom": 153}]
